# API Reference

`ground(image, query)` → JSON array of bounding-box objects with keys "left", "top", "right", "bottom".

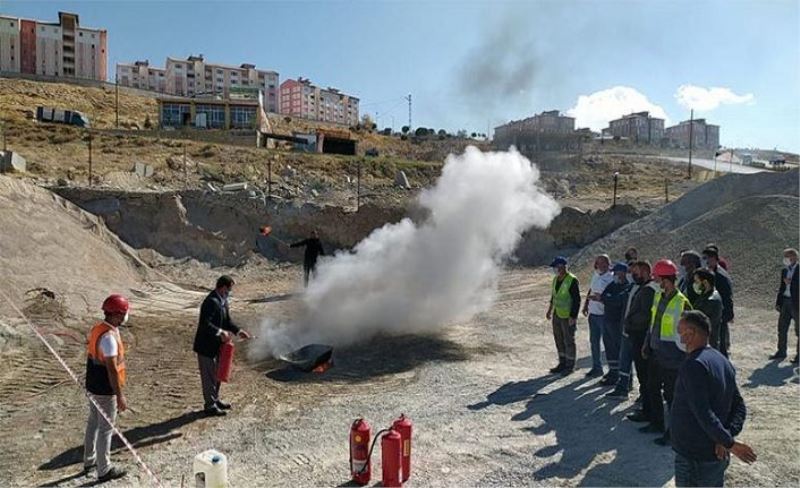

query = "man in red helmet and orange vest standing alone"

[{"left": 83, "top": 295, "right": 130, "bottom": 483}]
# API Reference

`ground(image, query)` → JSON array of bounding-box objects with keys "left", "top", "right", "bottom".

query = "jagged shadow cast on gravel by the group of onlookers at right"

[{"left": 467, "top": 360, "right": 674, "bottom": 486}]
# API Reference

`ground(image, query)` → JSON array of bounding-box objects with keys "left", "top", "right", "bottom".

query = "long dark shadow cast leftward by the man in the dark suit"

[{"left": 38, "top": 411, "right": 204, "bottom": 472}]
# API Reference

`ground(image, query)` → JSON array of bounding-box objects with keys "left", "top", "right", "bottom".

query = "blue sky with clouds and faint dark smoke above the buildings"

[{"left": 6, "top": 0, "right": 800, "bottom": 152}]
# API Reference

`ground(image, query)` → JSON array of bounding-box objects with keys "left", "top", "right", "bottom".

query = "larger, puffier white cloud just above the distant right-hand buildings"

[{"left": 567, "top": 86, "right": 669, "bottom": 131}]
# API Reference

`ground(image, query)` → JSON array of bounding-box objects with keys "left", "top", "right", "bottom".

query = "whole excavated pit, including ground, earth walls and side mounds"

[{"left": 0, "top": 157, "right": 800, "bottom": 487}]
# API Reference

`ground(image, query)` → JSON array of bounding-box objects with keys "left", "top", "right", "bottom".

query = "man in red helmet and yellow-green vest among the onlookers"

[{"left": 639, "top": 259, "right": 692, "bottom": 446}]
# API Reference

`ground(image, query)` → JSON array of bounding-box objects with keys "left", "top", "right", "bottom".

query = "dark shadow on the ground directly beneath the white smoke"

[{"left": 261, "top": 334, "right": 491, "bottom": 383}]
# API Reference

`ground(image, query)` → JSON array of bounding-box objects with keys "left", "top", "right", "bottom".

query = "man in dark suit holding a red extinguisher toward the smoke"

[{"left": 194, "top": 275, "right": 250, "bottom": 416}]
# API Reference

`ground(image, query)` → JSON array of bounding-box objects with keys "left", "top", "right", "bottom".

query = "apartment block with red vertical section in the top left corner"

[{"left": 0, "top": 12, "right": 108, "bottom": 81}]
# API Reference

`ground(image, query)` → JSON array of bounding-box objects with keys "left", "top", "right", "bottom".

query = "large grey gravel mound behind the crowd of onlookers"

[{"left": 575, "top": 170, "right": 800, "bottom": 304}]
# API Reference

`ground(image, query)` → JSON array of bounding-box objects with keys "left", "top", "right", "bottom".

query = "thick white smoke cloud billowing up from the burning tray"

[{"left": 250, "top": 147, "right": 560, "bottom": 359}]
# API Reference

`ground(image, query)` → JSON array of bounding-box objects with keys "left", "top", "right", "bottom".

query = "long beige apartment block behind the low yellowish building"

[{"left": 117, "top": 55, "right": 279, "bottom": 113}]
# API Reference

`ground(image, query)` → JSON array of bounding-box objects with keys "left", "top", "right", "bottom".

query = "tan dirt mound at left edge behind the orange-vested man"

[{"left": 0, "top": 176, "right": 147, "bottom": 318}]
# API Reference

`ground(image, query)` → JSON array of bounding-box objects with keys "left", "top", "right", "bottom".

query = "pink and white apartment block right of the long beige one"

[{"left": 280, "top": 78, "right": 359, "bottom": 126}]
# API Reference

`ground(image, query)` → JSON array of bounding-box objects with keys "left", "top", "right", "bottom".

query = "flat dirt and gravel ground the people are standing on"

[{"left": 0, "top": 266, "right": 800, "bottom": 487}]
